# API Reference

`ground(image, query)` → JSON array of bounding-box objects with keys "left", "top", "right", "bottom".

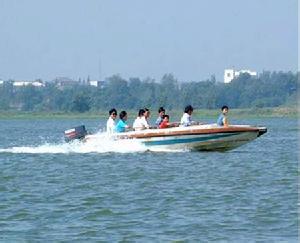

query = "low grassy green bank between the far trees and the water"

[{"left": 0, "top": 107, "right": 298, "bottom": 120}]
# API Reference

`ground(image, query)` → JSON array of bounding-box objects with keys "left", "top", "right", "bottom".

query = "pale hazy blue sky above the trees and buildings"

[{"left": 0, "top": 0, "right": 298, "bottom": 81}]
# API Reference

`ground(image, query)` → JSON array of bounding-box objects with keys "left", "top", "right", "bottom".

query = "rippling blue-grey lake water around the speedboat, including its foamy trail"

[{"left": 0, "top": 118, "right": 299, "bottom": 242}]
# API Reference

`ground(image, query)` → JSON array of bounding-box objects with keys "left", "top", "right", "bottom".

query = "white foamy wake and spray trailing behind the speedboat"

[{"left": 0, "top": 133, "right": 185, "bottom": 154}]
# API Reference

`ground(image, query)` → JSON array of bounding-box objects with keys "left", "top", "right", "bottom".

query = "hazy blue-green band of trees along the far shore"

[{"left": 0, "top": 71, "right": 299, "bottom": 112}]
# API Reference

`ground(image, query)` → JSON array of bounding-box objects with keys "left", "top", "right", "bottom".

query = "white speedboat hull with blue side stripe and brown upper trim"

[{"left": 79, "top": 124, "right": 267, "bottom": 151}]
